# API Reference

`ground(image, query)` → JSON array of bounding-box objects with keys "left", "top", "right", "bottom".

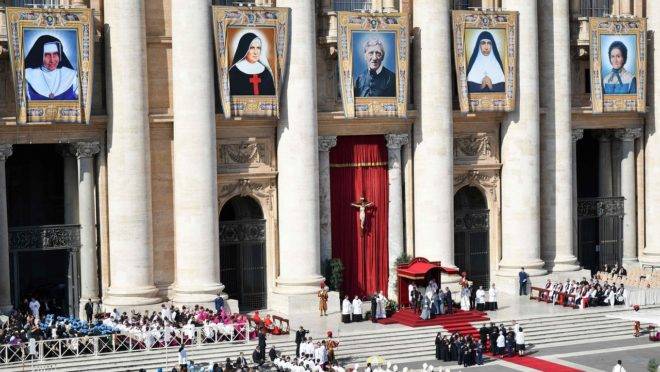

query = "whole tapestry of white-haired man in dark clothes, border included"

[{"left": 337, "top": 12, "right": 410, "bottom": 118}]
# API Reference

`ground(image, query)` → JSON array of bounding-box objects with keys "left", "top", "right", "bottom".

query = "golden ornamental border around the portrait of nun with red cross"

[{"left": 213, "top": 6, "right": 290, "bottom": 119}]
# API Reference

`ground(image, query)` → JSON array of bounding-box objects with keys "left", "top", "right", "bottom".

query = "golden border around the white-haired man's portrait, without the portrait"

[{"left": 337, "top": 12, "right": 410, "bottom": 119}]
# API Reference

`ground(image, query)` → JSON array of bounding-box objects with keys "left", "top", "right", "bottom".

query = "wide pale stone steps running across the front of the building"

[{"left": 0, "top": 309, "right": 646, "bottom": 372}]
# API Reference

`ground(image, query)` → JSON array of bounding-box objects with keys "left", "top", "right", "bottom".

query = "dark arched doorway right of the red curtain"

[{"left": 454, "top": 186, "right": 490, "bottom": 288}]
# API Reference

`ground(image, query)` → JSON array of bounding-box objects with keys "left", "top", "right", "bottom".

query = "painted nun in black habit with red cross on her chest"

[{"left": 229, "top": 32, "right": 275, "bottom": 96}]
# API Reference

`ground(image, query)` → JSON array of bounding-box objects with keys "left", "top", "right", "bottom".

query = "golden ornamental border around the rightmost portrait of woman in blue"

[{"left": 589, "top": 17, "right": 647, "bottom": 114}]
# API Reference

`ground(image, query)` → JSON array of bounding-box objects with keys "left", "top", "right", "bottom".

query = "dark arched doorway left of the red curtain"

[{"left": 220, "top": 196, "right": 267, "bottom": 311}]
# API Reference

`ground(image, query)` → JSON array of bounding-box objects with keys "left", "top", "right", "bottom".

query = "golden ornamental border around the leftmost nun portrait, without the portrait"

[{"left": 6, "top": 7, "right": 94, "bottom": 124}]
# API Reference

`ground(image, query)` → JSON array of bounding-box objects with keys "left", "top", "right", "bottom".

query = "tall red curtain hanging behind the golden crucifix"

[{"left": 330, "top": 136, "right": 389, "bottom": 297}]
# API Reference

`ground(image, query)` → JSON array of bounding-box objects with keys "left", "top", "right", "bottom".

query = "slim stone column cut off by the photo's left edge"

[{"left": 0, "top": 143, "right": 12, "bottom": 313}]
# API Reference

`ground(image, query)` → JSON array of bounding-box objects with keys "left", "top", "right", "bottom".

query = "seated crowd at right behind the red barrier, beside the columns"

[{"left": 532, "top": 277, "right": 627, "bottom": 309}]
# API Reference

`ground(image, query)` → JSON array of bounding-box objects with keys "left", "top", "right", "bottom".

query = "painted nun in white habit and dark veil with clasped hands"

[{"left": 467, "top": 31, "right": 505, "bottom": 93}]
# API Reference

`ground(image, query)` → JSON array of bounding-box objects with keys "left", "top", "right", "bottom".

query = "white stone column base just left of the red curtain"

[{"left": 268, "top": 291, "right": 340, "bottom": 316}]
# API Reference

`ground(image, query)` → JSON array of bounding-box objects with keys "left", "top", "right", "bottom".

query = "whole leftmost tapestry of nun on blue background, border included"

[{"left": 6, "top": 7, "right": 94, "bottom": 124}]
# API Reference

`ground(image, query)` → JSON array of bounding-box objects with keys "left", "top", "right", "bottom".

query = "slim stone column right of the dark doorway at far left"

[{"left": 71, "top": 141, "right": 101, "bottom": 306}]
